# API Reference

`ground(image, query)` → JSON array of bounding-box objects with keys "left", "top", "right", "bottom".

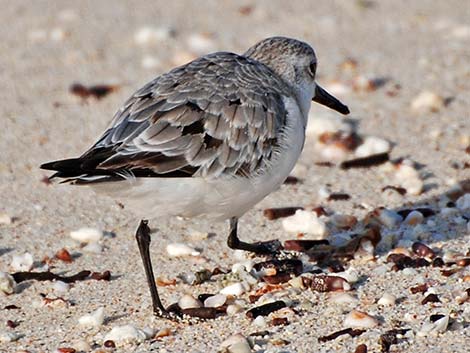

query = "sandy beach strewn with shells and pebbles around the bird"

[{"left": 0, "top": 0, "right": 470, "bottom": 353}]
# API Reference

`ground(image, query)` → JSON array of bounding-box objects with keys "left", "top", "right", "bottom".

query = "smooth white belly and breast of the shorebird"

[{"left": 91, "top": 95, "right": 308, "bottom": 220}]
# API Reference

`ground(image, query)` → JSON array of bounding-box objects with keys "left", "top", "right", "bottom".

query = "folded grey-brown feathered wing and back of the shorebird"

[{"left": 80, "top": 53, "right": 291, "bottom": 177}]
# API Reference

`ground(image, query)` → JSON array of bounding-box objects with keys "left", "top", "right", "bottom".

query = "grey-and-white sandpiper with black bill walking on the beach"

[{"left": 41, "top": 37, "right": 349, "bottom": 316}]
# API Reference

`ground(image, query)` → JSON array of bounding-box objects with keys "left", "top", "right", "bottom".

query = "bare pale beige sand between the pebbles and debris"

[{"left": 0, "top": 0, "right": 470, "bottom": 353}]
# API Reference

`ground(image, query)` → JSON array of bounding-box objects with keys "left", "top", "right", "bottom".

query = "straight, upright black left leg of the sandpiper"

[{"left": 135, "top": 220, "right": 172, "bottom": 318}]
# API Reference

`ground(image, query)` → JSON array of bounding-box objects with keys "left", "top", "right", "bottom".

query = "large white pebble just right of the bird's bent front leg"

[{"left": 282, "top": 210, "right": 328, "bottom": 239}]
